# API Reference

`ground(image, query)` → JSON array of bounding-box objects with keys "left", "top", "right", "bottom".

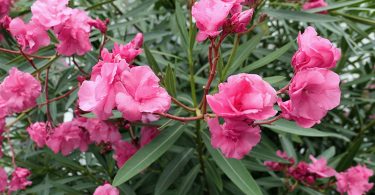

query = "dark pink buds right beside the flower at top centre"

[{"left": 223, "top": 9, "right": 254, "bottom": 33}]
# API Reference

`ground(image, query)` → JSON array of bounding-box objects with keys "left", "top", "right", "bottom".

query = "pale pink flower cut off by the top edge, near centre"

[{"left": 192, "top": 0, "right": 236, "bottom": 42}]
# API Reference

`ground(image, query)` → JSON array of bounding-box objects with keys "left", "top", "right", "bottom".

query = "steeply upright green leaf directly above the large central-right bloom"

[{"left": 224, "top": 33, "right": 263, "bottom": 76}]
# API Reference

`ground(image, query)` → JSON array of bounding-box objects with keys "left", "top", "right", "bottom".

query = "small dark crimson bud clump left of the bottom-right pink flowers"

[{"left": 288, "top": 161, "right": 316, "bottom": 184}]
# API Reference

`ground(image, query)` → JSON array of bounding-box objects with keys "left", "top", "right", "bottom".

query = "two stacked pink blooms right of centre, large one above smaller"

[{"left": 207, "top": 74, "right": 277, "bottom": 159}]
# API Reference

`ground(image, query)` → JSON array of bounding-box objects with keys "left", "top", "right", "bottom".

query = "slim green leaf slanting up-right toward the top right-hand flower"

[{"left": 241, "top": 42, "right": 293, "bottom": 72}]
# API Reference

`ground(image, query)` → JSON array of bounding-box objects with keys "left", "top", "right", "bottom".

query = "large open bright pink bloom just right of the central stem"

[{"left": 207, "top": 73, "right": 277, "bottom": 120}]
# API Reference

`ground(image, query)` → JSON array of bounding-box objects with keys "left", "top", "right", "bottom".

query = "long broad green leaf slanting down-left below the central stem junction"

[{"left": 113, "top": 124, "right": 184, "bottom": 186}]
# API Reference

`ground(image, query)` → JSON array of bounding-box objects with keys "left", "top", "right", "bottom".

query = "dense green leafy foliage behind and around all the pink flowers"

[{"left": 0, "top": 0, "right": 375, "bottom": 195}]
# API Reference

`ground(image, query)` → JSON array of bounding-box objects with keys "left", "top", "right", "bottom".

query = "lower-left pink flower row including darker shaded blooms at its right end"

[{"left": 27, "top": 117, "right": 159, "bottom": 167}]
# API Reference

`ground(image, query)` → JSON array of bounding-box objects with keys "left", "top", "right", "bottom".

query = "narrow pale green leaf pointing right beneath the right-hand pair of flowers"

[{"left": 262, "top": 120, "right": 349, "bottom": 141}]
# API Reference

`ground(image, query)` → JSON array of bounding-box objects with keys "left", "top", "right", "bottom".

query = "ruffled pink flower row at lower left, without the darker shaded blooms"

[{"left": 27, "top": 118, "right": 121, "bottom": 155}]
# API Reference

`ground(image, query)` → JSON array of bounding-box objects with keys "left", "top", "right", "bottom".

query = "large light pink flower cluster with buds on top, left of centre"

[{"left": 78, "top": 34, "right": 171, "bottom": 122}]
